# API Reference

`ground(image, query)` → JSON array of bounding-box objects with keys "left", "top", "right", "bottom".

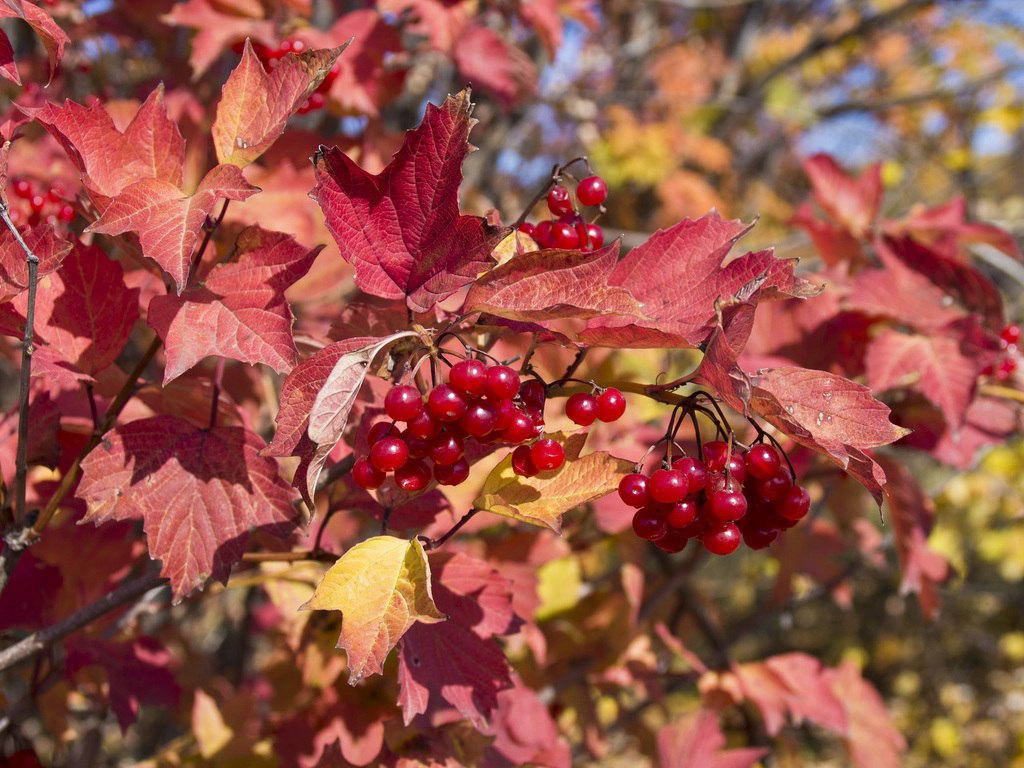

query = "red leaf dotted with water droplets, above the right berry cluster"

[{"left": 751, "top": 367, "right": 907, "bottom": 505}]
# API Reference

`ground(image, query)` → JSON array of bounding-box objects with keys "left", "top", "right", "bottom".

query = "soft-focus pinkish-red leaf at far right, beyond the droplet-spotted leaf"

[{"left": 865, "top": 328, "right": 981, "bottom": 435}]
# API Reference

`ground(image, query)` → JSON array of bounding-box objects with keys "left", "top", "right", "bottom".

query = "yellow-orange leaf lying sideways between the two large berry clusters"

[{"left": 473, "top": 433, "right": 633, "bottom": 534}]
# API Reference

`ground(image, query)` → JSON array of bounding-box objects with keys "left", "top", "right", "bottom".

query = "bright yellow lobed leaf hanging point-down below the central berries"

[{"left": 302, "top": 536, "right": 445, "bottom": 685}]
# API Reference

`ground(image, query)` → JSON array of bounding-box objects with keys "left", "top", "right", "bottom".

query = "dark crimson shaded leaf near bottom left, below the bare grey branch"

[{"left": 67, "top": 636, "right": 180, "bottom": 732}]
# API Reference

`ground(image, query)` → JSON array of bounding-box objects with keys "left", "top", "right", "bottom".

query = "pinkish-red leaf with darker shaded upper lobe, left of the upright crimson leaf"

[{"left": 148, "top": 226, "right": 323, "bottom": 384}]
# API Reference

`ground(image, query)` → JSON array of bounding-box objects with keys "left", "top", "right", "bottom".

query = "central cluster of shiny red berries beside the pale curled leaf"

[{"left": 352, "top": 358, "right": 565, "bottom": 490}]
